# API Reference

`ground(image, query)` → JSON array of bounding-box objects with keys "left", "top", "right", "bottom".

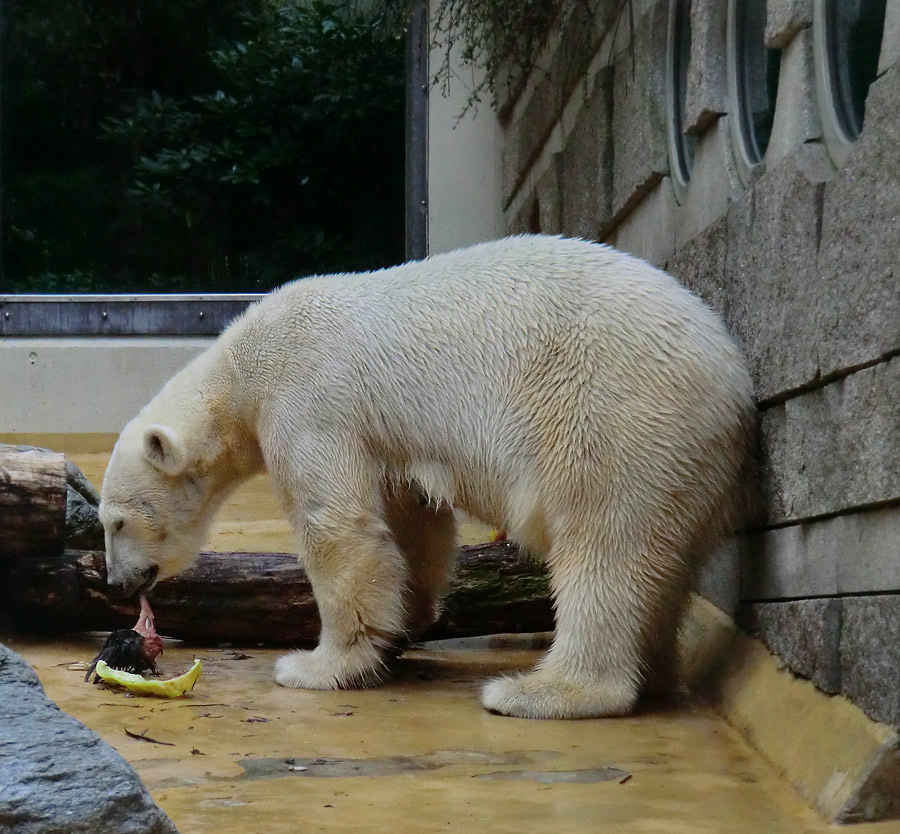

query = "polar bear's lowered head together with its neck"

[{"left": 100, "top": 331, "right": 263, "bottom": 595}]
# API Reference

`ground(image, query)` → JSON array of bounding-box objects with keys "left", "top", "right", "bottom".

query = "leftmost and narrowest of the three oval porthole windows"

[{"left": 666, "top": 0, "right": 696, "bottom": 201}]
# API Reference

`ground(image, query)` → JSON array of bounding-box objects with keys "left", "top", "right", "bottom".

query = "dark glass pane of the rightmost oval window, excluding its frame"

[{"left": 824, "top": 0, "right": 887, "bottom": 139}]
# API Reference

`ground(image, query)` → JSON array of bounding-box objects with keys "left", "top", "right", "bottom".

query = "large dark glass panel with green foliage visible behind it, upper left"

[{"left": 0, "top": 0, "right": 405, "bottom": 293}]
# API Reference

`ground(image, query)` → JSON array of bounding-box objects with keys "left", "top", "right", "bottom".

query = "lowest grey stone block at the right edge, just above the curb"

[{"left": 841, "top": 594, "right": 900, "bottom": 726}]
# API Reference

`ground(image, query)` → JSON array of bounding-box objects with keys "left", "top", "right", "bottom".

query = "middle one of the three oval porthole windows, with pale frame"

[{"left": 728, "top": 0, "right": 781, "bottom": 185}]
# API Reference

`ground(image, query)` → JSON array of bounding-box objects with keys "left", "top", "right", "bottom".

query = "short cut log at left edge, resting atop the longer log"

[{"left": 0, "top": 444, "right": 66, "bottom": 560}]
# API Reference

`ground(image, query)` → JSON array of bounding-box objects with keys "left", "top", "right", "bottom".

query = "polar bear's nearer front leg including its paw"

[{"left": 275, "top": 480, "right": 406, "bottom": 689}]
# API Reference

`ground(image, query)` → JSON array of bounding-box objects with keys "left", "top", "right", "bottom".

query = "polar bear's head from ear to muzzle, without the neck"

[{"left": 100, "top": 420, "right": 217, "bottom": 596}]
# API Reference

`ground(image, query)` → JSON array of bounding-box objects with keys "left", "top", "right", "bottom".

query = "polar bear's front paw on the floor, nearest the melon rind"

[{"left": 275, "top": 645, "right": 384, "bottom": 690}]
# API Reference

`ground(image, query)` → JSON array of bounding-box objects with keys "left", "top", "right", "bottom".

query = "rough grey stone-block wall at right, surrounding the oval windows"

[{"left": 429, "top": 0, "right": 900, "bottom": 725}]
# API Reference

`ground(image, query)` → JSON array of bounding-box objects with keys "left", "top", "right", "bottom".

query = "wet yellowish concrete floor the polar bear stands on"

[{"left": 5, "top": 636, "right": 900, "bottom": 834}]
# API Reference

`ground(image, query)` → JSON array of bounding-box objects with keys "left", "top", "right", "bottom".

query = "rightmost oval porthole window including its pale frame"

[{"left": 813, "top": 0, "right": 887, "bottom": 166}]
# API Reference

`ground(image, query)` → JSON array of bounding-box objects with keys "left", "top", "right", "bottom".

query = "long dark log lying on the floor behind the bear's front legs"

[{"left": 0, "top": 542, "right": 553, "bottom": 646}]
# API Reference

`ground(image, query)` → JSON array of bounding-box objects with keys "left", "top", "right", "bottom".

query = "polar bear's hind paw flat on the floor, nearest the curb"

[{"left": 481, "top": 670, "right": 637, "bottom": 718}]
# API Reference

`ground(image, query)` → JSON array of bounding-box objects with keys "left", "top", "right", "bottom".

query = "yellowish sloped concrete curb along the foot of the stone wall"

[{"left": 681, "top": 596, "right": 900, "bottom": 823}]
